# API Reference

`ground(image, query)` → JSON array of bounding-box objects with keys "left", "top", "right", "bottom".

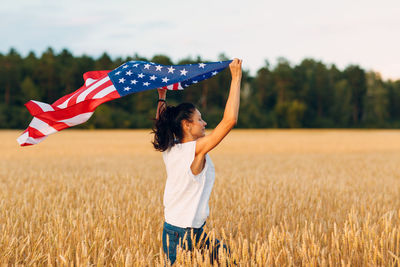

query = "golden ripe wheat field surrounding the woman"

[{"left": 0, "top": 130, "right": 400, "bottom": 266}]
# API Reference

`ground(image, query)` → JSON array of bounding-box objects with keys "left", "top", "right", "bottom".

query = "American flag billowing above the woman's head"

[{"left": 17, "top": 60, "right": 231, "bottom": 146}]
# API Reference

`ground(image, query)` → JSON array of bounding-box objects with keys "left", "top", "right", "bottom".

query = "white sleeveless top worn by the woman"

[{"left": 163, "top": 141, "right": 215, "bottom": 228}]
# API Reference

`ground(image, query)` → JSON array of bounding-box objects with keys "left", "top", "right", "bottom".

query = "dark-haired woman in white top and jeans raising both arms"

[{"left": 153, "top": 59, "right": 242, "bottom": 264}]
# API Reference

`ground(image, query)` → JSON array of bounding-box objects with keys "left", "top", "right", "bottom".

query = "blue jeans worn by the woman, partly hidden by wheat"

[{"left": 162, "top": 222, "right": 230, "bottom": 265}]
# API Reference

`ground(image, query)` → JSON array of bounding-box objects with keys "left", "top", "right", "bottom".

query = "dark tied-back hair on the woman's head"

[{"left": 152, "top": 103, "right": 196, "bottom": 152}]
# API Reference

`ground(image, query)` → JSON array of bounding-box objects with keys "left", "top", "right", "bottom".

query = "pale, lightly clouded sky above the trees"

[{"left": 0, "top": 0, "right": 400, "bottom": 79}]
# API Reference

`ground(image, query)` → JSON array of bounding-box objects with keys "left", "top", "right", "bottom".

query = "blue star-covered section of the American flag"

[{"left": 108, "top": 60, "right": 232, "bottom": 97}]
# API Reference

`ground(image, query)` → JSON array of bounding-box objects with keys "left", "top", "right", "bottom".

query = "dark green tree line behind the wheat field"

[{"left": 0, "top": 48, "right": 400, "bottom": 129}]
